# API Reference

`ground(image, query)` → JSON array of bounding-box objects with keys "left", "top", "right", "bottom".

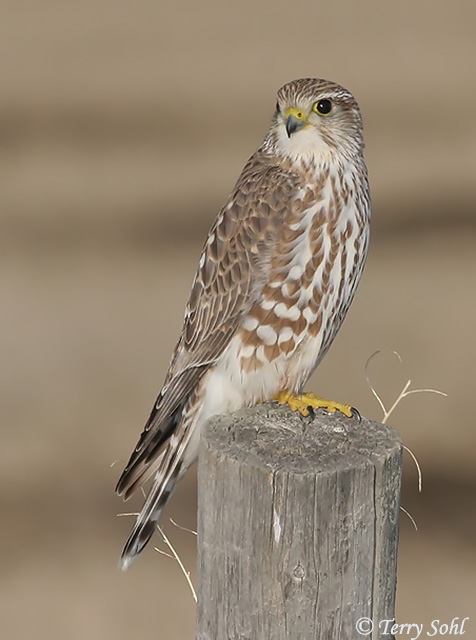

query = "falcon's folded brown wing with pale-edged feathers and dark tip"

[{"left": 116, "top": 150, "right": 298, "bottom": 497}]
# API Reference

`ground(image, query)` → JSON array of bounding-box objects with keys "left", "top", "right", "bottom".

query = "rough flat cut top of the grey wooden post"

[{"left": 204, "top": 403, "right": 402, "bottom": 473}]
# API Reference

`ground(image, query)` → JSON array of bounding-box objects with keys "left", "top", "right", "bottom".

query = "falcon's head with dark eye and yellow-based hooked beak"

[{"left": 265, "top": 78, "right": 364, "bottom": 164}]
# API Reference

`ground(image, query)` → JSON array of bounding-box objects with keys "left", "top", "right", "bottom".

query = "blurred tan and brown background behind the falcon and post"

[{"left": 0, "top": 0, "right": 476, "bottom": 640}]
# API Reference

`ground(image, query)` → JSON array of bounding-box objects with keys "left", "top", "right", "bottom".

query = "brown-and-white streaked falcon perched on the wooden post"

[{"left": 116, "top": 78, "right": 370, "bottom": 569}]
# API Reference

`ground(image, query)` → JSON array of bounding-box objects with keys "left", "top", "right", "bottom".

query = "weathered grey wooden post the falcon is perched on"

[{"left": 197, "top": 404, "right": 402, "bottom": 640}]
